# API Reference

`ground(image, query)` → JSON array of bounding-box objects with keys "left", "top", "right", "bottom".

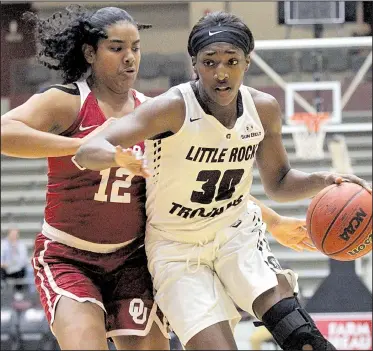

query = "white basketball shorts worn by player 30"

[{"left": 145, "top": 205, "right": 298, "bottom": 345}]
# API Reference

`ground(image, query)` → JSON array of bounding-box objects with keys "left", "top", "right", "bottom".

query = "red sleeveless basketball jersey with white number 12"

[{"left": 43, "top": 81, "right": 145, "bottom": 244}]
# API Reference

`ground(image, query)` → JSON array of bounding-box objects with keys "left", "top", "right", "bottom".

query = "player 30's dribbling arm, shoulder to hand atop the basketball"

[{"left": 253, "top": 89, "right": 371, "bottom": 202}]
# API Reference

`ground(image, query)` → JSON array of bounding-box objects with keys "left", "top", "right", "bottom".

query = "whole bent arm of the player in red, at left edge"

[{"left": 1, "top": 88, "right": 81, "bottom": 158}]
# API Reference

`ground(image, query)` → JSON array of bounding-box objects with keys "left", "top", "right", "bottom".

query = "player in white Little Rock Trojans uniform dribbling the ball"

[{"left": 76, "top": 12, "right": 369, "bottom": 350}]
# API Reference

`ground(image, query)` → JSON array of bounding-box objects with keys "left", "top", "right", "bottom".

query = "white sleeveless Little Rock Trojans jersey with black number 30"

[{"left": 145, "top": 83, "right": 264, "bottom": 243}]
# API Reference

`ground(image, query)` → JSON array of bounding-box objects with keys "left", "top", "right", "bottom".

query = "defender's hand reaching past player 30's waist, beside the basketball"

[{"left": 268, "top": 216, "right": 317, "bottom": 251}]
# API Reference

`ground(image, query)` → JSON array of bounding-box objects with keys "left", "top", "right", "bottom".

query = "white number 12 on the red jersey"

[{"left": 94, "top": 168, "right": 134, "bottom": 204}]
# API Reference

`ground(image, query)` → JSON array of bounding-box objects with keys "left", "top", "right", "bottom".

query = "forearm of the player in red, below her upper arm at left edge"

[{"left": 1, "top": 121, "right": 81, "bottom": 158}]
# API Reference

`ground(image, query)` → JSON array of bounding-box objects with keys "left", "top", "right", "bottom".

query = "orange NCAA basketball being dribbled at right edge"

[{"left": 307, "top": 182, "right": 372, "bottom": 261}]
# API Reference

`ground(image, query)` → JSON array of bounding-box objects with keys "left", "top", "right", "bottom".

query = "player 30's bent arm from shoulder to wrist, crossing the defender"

[{"left": 75, "top": 89, "right": 185, "bottom": 170}]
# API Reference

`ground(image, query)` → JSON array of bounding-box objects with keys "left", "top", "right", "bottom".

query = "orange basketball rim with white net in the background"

[{"left": 291, "top": 112, "right": 329, "bottom": 160}]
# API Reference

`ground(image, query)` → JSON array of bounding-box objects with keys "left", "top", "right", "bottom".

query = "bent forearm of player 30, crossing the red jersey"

[{"left": 75, "top": 138, "right": 118, "bottom": 171}]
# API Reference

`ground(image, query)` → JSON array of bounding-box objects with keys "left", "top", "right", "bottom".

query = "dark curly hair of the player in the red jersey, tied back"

[{"left": 23, "top": 5, "right": 152, "bottom": 84}]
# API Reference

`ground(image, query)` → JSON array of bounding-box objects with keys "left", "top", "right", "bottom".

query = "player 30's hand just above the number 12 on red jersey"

[{"left": 115, "top": 145, "right": 150, "bottom": 178}]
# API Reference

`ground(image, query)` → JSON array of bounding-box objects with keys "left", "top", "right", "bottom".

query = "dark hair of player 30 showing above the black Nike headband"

[{"left": 188, "top": 11, "right": 254, "bottom": 56}]
